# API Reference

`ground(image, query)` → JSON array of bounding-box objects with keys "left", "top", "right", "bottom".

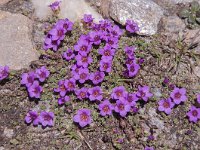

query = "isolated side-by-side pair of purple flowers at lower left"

[{"left": 25, "top": 110, "right": 54, "bottom": 127}]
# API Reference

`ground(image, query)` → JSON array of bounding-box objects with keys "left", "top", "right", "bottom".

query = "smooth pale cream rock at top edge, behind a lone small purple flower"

[{"left": 32, "top": 0, "right": 102, "bottom": 22}]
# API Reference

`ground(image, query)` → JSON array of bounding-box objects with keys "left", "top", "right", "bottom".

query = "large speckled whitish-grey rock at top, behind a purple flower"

[{"left": 109, "top": 0, "right": 163, "bottom": 35}]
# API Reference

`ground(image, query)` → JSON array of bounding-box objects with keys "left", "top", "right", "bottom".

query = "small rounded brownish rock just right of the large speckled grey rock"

[{"left": 162, "top": 16, "right": 185, "bottom": 33}]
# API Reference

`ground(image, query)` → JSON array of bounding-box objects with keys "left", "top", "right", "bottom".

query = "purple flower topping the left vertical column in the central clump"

[{"left": 74, "top": 39, "right": 92, "bottom": 56}]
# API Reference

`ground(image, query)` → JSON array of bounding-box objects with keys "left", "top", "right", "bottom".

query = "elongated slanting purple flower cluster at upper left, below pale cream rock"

[{"left": 43, "top": 19, "right": 73, "bottom": 51}]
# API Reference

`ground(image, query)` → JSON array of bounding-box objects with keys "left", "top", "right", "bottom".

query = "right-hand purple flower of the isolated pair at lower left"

[{"left": 39, "top": 111, "right": 54, "bottom": 127}]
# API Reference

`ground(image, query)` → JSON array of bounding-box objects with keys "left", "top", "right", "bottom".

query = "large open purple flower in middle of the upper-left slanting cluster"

[{"left": 49, "top": 22, "right": 66, "bottom": 41}]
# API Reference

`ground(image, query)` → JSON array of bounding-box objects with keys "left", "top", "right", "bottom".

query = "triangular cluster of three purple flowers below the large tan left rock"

[{"left": 21, "top": 66, "right": 50, "bottom": 98}]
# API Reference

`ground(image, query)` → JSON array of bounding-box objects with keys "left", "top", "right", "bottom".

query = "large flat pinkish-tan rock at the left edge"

[{"left": 0, "top": 11, "right": 38, "bottom": 70}]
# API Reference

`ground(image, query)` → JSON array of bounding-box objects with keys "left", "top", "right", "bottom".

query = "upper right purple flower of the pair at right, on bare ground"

[{"left": 170, "top": 87, "right": 187, "bottom": 104}]
